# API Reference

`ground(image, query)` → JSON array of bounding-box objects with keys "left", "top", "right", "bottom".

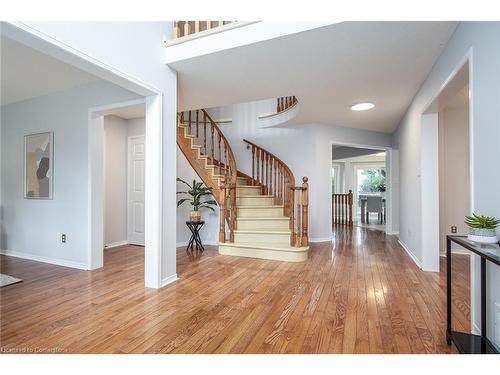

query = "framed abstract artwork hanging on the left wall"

[{"left": 24, "top": 132, "right": 54, "bottom": 199}]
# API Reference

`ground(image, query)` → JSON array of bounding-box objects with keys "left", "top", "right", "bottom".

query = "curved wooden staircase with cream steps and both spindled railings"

[{"left": 177, "top": 110, "right": 309, "bottom": 262}]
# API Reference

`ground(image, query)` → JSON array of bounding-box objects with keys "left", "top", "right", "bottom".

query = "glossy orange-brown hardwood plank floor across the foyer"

[{"left": 0, "top": 227, "right": 469, "bottom": 353}]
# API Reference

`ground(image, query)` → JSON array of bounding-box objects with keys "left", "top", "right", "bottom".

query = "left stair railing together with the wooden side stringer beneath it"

[{"left": 177, "top": 109, "right": 237, "bottom": 242}]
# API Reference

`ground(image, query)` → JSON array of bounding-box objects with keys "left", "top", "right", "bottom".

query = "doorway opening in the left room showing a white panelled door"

[{"left": 103, "top": 104, "right": 145, "bottom": 266}]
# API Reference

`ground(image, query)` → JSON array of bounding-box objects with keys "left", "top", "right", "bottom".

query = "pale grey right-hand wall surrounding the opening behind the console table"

[{"left": 394, "top": 22, "right": 500, "bottom": 345}]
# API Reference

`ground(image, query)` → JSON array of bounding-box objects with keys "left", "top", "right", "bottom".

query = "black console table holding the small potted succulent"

[{"left": 446, "top": 236, "right": 500, "bottom": 354}]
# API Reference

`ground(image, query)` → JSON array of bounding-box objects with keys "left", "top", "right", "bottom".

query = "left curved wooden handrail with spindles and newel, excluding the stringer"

[{"left": 180, "top": 109, "right": 238, "bottom": 242}]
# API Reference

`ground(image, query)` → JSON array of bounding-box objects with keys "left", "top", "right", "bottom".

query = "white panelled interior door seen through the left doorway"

[{"left": 127, "top": 136, "right": 145, "bottom": 246}]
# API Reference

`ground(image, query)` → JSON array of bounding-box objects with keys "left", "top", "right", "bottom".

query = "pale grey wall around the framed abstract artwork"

[{"left": 0, "top": 81, "right": 141, "bottom": 268}]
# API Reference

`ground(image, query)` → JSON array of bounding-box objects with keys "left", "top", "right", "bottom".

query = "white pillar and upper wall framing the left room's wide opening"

[{"left": 15, "top": 21, "right": 177, "bottom": 286}]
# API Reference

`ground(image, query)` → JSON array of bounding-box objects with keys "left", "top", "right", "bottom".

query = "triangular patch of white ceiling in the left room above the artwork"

[{"left": 0, "top": 36, "right": 98, "bottom": 105}]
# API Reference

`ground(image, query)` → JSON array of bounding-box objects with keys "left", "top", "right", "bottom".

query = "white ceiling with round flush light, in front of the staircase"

[{"left": 169, "top": 22, "right": 458, "bottom": 132}]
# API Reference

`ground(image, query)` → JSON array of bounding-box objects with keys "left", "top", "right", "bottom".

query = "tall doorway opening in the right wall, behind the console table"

[{"left": 422, "top": 62, "right": 474, "bottom": 332}]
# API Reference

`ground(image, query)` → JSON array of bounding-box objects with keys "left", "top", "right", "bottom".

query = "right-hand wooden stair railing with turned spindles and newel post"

[{"left": 243, "top": 139, "right": 309, "bottom": 247}]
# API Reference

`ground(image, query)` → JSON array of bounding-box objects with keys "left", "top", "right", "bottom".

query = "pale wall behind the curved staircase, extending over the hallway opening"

[{"left": 205, "top": 101, "right": 392, "bottom": 241}]
